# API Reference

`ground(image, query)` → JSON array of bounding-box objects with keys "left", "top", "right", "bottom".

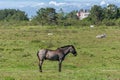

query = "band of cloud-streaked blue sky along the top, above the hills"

[{"left": 0, "top": 0, "right": 120, "bottom": 9}]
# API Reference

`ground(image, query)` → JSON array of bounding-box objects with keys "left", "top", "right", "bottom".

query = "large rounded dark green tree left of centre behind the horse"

[{"left": 34, "top": 8, "right": 57, "bottom": 25}]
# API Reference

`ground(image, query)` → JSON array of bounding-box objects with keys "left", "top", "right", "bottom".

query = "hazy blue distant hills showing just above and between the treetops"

[{"left": 17, "top": 2, "right": 120, "bottom": 18}]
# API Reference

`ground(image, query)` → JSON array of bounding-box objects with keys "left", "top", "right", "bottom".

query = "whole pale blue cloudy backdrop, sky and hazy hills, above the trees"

[{"left": 0, "top": 0, "right": 120, "bottom": 16}]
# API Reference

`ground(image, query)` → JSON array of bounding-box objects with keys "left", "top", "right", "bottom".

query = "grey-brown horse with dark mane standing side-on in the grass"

[{"left": 37, "top": 45, "right": 77, "bottom": 72}]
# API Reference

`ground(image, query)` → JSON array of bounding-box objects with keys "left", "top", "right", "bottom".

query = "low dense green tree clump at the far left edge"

[{"left": 0, "top": 9, "right": 28, "bottom": 21}]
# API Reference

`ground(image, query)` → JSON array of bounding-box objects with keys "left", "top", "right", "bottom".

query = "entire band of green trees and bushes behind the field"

[{"left": 0, "top": 4, "right": 120, "bottom": 26}]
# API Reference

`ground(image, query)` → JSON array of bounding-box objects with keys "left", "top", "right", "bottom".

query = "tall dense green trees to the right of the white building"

[{"left": 88, "top": 4, "right": 120, "bottom": 26}]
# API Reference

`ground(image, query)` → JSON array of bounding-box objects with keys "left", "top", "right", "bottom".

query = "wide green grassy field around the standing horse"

[{"left": 0, "top": 26, "right": 120, "bottom": 80}]
